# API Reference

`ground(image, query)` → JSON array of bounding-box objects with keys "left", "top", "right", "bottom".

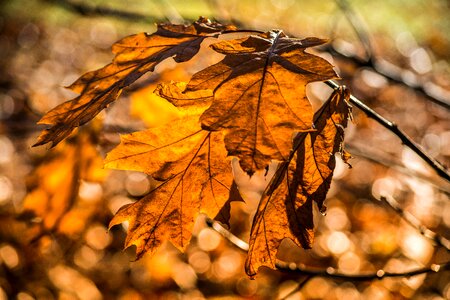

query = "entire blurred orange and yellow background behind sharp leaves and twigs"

[{"left": 0, "top": 0, "right": 450, "bottom": 300}]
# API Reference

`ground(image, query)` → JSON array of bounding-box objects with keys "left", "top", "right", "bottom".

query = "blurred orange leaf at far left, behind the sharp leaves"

[{"left": 22, "top": 132, "right": 107, "bottom": 235}]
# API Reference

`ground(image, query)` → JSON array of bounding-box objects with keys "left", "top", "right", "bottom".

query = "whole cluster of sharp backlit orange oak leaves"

[{"left": 35, "top": 18, "right": 351, "bottom": 276}]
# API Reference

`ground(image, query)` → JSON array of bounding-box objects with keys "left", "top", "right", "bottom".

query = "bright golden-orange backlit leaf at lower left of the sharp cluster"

[{"left": 105, "top": 115, "right": 233, "bottom": 258}]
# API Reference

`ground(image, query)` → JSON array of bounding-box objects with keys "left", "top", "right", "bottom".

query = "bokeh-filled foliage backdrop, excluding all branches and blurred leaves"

[{"left": 0, "top": 0, "right": 450, "bottom": 299}]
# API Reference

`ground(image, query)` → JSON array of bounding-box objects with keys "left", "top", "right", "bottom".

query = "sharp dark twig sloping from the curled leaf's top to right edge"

[{"left": 325, "top": 80, "right": 450, "bottom": 181}]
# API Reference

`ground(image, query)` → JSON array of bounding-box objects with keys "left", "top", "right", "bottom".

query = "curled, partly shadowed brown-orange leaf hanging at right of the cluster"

[{"left": 245, "top": 88, "right": 350, "bottom": 276}]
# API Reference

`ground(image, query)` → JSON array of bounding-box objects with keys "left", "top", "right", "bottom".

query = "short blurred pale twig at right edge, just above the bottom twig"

[{"left": 380, "top": 196, "right": 450, "bottom": 251}]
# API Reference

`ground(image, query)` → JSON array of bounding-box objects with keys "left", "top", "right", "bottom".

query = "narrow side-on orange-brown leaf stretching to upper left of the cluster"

[{"left": 34, "top": 18, "right": 235, "bottom": 147}]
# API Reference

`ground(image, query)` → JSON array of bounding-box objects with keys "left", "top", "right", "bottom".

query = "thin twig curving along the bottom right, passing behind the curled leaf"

[{"left": 206, "top": 218, "right": 450, "bottom": 281}]
